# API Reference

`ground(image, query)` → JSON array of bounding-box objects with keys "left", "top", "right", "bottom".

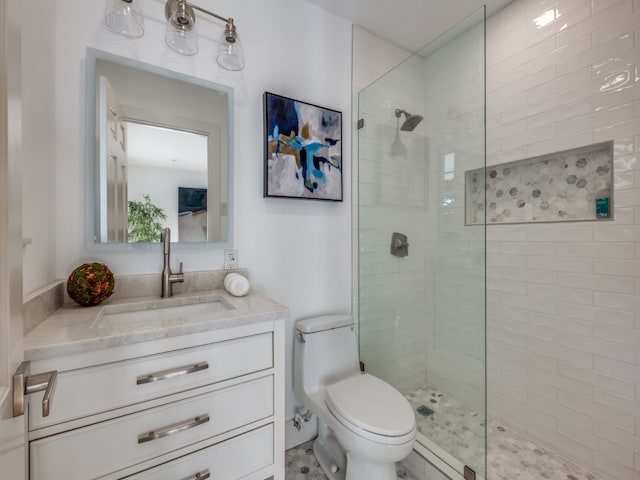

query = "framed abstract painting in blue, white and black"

[{"left": 264, "top": 92, "right": 342, "bottom": 201}]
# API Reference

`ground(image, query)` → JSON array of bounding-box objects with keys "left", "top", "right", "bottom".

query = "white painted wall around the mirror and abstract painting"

[{"left": 25, "top": 0, "right": 351, "bottom": 436}]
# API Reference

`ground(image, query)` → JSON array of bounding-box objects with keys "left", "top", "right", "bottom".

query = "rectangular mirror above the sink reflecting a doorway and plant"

[{"left": 87, "top": 49, "right": 233, "bottom": 244}]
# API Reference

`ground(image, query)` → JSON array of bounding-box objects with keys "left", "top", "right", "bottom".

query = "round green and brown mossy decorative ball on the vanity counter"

[{"left": 67, "top": 263, "right": 115, "bottom": 306}]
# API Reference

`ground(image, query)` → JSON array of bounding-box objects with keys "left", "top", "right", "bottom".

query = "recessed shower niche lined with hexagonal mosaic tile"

[{"left": 465, "top": 142, "right": 613, "bottom": 225}]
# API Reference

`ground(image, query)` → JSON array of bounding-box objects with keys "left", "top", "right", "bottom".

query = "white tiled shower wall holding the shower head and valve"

[{"left": 353, "top": 26, "right": 427, "bottom": 390}]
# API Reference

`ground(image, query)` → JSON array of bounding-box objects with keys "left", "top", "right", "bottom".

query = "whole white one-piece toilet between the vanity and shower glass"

[{"left": 293, "top": 315, "right": 416, "bottom": 480}]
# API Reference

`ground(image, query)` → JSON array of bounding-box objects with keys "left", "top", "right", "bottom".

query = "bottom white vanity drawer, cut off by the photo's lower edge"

[{"left": 125, "top": 425, "right": 273, "bottom": 480}]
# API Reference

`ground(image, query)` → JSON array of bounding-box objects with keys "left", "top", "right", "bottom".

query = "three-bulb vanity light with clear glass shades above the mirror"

[{"left": 105, "top": 0, "right": 245, "bottom": 71}]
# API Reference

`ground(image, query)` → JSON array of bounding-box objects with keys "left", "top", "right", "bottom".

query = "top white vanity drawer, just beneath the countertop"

[{"left": 29, "top": 333, "right": 273, "bottom": 431}]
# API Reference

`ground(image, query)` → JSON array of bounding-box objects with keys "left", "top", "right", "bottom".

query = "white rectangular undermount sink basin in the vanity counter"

[{"left": 95, "top": 297, "right": 234, "bottom": 328}]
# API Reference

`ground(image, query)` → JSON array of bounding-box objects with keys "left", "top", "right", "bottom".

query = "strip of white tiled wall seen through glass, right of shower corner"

[{"left": 419, "top": 13, "right": 484, "bottom": 414}]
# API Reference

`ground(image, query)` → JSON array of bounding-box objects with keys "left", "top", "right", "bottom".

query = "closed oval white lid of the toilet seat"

[{"left": 326, "top": 373, "right": 415, "bottom": 437}]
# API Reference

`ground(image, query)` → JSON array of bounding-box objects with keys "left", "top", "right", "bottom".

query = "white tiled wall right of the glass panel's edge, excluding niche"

[{"left": 487, "top": 0, "right": 640, "bottom": 480}]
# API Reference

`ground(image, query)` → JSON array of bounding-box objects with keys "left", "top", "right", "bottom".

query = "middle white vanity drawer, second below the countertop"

[{"left": 29, "top": 375, "right": 273, "bottom": 480}]
